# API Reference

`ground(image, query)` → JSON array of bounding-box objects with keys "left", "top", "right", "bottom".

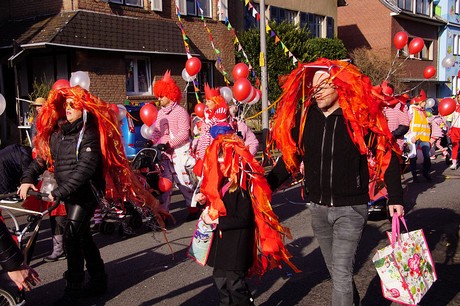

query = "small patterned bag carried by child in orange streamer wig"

[{"left": 187, "top": 210, "right": 215, "bottom": 266}]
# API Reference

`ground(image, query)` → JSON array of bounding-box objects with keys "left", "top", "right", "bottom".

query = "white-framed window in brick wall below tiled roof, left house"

[{"left": 125, "top": 57, "right": 152, "bottom": 95}]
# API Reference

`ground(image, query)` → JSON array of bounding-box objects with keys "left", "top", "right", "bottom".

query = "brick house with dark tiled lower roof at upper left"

[{"left": 0, "top": 0, "right": 237, "bottom": 144}]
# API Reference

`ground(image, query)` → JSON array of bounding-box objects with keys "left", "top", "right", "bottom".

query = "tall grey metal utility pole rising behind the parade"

[{"left": 259, "top": 0, "right": 268, "bottom": 150}]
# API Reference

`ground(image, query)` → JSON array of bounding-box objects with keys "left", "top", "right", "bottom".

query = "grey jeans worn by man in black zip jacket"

[{"left": 309, "top": 203, "right": 367, "bottom": 306}]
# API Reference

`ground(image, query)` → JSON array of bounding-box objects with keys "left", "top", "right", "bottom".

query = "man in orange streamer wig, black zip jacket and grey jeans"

[{"left": 267, "top": 59, "right": 404, "bottom": 306}]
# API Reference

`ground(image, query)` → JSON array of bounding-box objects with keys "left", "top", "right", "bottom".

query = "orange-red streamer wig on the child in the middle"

[{"left": 201, "top": 133, "right": 300, "bottom": 275}]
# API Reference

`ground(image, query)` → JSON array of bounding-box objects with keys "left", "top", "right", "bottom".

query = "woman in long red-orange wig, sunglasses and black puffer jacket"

[{"left": 18, "top": 86, "right": 164, "bottom": 305}]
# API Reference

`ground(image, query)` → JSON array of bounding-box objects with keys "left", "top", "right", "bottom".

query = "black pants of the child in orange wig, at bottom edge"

[{"left": 212, "top": 268, "right": 254, "bottom": 306}]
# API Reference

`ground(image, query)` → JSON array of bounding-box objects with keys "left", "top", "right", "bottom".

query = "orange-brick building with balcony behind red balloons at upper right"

[{"left": 338, "top": 0, "right": 447, "bottom": 97}]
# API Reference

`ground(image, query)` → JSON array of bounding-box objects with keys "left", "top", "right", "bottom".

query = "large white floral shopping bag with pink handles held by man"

[{"left": 372, "top": 214, "right": 437, "bottom": 305}]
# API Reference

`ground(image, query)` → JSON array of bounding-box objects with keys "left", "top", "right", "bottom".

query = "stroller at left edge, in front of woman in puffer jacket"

[{"left": 0, "top": 190, "right": 60, "bottom": 306}]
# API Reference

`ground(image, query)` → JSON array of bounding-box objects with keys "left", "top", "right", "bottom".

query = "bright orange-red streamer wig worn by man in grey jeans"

[{"left": 267, "top": 58, "right": 400, "bottom": 185}]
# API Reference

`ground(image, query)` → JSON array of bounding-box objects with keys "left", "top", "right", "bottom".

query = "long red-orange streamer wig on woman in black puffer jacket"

[{"left": 34, "top": 86, "right": 168, "bottom": 227}]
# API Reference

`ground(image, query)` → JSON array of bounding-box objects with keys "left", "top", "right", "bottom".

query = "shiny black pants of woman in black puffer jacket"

[{"left": 64, "top": 203, "right": 105, "bottom": 283}]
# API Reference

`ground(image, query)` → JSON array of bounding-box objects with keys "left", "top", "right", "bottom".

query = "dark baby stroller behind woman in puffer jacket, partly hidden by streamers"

[{"left": 99, "top": 146, "right": 165, "bottom": 236}]
